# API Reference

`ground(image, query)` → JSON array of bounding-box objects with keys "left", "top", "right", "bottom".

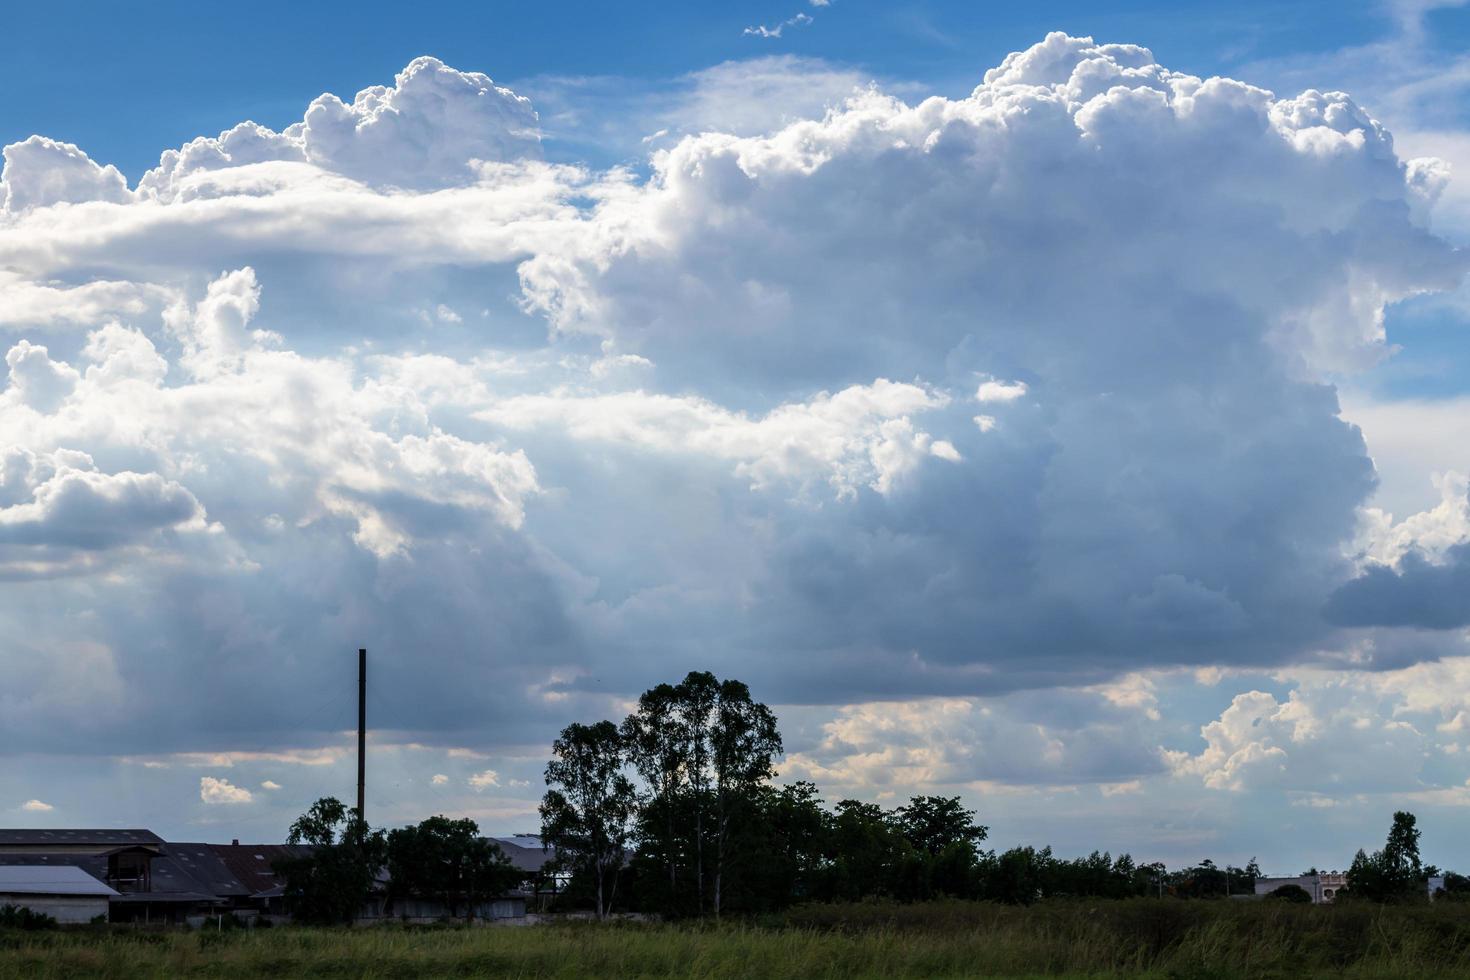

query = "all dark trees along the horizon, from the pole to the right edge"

[{"left": 278, "top": 671, "right": 1470, "bottom": 923}]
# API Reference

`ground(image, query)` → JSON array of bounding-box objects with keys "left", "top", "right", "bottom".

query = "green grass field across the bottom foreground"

[{"left": 0, "top": 899, "right": 1470, "bottom": 980}]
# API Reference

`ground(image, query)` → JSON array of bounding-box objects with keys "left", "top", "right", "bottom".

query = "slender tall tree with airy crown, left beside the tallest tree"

[{"left": 541, "top": 721, "right": 638, "bottom": 918}]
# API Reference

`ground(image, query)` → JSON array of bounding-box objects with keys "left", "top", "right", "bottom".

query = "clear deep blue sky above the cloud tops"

[{"left": 0, "top": 0, "right": 1470, "bottom": 175}]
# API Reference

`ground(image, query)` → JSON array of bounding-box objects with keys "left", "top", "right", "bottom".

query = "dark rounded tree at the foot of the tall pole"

[{"left": 275, "top": 796, "right": 387, "bottom": 926}]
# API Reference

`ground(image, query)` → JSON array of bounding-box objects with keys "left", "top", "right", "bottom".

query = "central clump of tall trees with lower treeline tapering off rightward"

[{"left": 541, "top": 671, "right": 1258, "bottom": 915}]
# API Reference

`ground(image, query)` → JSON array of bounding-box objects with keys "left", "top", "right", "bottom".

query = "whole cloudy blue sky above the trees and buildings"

[{"left": 0, "top": 0, "right": 1470, "bottom": 873}]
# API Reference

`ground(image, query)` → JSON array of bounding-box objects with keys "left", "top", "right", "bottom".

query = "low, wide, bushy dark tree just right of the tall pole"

[{"left": 387, "top": 817, "right": 520, "bottom": 918}]
